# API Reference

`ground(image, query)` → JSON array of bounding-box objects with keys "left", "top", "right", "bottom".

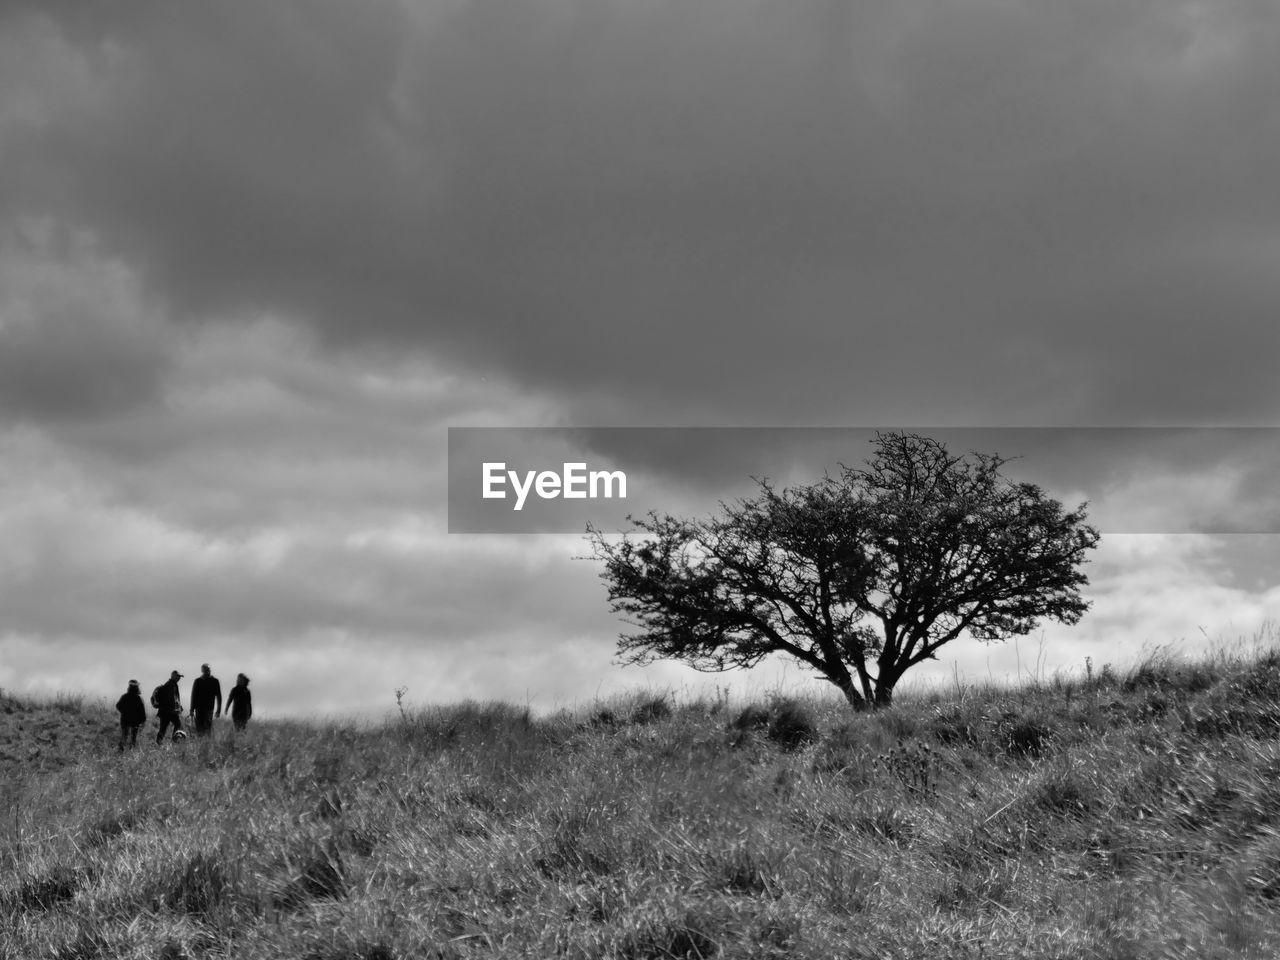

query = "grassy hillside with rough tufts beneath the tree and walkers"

[{"left": 0, "top": 650, "right": 1280, "bottom": 960}]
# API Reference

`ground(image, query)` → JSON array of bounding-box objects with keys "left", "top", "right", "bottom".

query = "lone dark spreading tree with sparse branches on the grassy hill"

[{"left": 588, "top": 433, "right": 1098, "bottom": 709}]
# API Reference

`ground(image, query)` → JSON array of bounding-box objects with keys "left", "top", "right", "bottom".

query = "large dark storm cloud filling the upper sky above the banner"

[{"left": 10, "top": 0, "right": 1280, "bottom": 424}]
